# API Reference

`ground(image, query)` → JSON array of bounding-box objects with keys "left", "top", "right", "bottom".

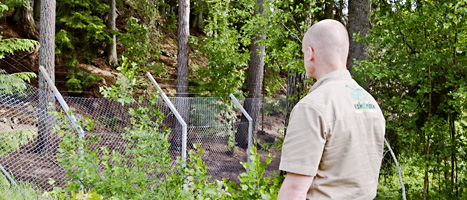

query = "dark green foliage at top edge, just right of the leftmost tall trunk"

[{"left": 55, "top": 0, "right": 110, "bottom": 67}]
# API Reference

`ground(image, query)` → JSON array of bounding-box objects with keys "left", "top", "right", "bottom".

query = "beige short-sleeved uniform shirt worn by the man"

[{"left": 279, "top": 70, "right": 385, "bottom": 200}]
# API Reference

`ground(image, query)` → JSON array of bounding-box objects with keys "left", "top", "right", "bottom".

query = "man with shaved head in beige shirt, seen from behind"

[{"left": 278, "top": 20, "right": 385, "bottom": 200}]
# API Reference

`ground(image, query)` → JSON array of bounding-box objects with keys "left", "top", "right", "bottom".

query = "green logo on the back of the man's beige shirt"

[{"left": 345, "top": 84, "right": 376, "bottom": 113}]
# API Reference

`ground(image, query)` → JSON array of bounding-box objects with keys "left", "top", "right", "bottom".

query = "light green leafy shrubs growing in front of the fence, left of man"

[{"left": 51, "top": 59, "right": 286, "bottom": 199}]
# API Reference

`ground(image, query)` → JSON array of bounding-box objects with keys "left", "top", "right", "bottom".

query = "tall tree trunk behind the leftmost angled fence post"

[{"left": 34, "top": 0, "right": 55, "bottom": 153}]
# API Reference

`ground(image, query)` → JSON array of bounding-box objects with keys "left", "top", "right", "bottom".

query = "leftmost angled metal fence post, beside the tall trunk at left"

[{"left": 39, "top": 65, "right": 84, "bottom": 187}]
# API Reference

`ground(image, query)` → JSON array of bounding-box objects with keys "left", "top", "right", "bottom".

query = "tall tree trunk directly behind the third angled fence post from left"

[{"left": 235, "top": 0, "right": 266, "bottom": 148}]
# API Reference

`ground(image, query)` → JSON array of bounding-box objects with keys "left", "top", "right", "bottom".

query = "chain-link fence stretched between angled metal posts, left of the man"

[{"left": 0, "top": 69, "right": 286, "bottom": 189}]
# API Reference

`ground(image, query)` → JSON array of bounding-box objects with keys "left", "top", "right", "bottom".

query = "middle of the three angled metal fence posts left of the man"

[{"left": 146, "top": 72, "right": 187, "bottom": 167}]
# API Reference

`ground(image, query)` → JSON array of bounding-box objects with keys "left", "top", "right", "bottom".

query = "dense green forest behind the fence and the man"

[{"left": 0, "top": 0, "right": 467, "bottom": 199}]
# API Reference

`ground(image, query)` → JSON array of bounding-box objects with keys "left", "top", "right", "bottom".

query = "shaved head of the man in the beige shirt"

[{"left": 302, "top": 19, "right": 349, "bottom": 78}]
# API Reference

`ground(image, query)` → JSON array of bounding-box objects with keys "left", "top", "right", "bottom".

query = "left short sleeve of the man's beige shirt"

[{"left": 279, "top": 103, "right": 326, "bottom": 176}]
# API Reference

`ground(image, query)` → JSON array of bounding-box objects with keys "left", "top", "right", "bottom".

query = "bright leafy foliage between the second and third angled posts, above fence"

[{"left": 190, "top": 0, "right": 249, "bottom": 96}]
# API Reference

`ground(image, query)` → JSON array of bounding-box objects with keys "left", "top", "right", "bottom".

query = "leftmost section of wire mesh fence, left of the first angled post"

[{"left": 0, "top": 69, "right": 66, "bottom": 189}]
